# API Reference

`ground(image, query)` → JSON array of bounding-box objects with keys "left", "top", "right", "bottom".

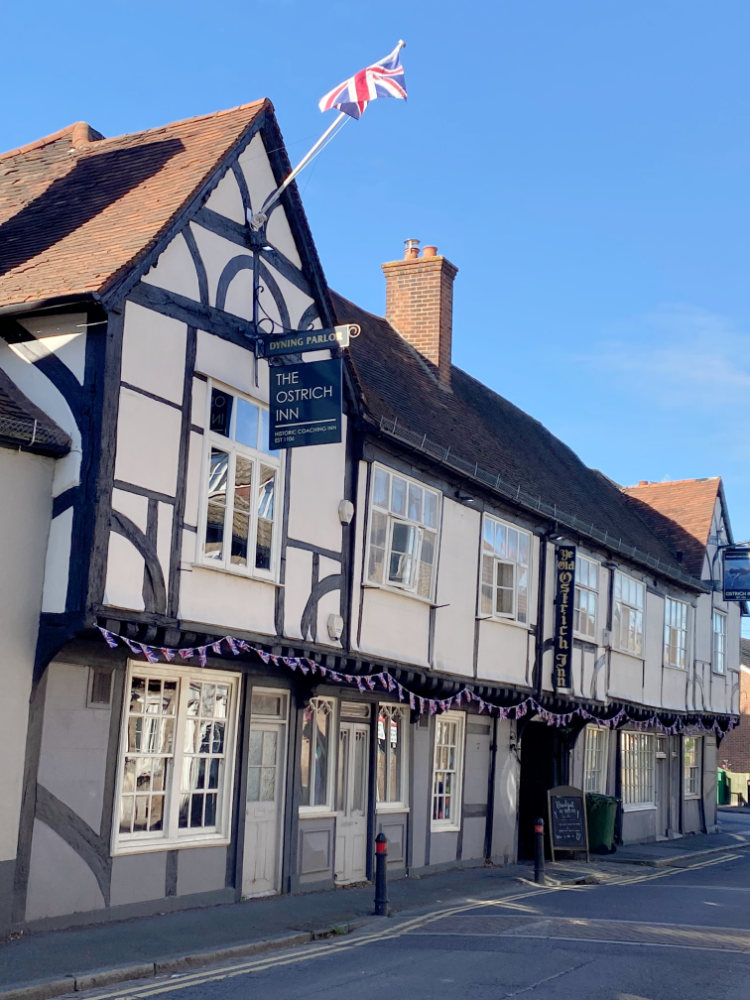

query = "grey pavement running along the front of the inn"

[{"left": 0, "top": 807, "right": 750, "bottom": 1000}]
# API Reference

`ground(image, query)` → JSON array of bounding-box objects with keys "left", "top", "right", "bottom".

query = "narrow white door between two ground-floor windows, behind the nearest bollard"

[{"left": 336, "top": 722, "right": 370, "bottom": 882}]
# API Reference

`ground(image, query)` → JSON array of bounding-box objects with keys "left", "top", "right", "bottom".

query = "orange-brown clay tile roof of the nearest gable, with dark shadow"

[{"left": 0, "top": 101, "right": 272, "bottom": 306}]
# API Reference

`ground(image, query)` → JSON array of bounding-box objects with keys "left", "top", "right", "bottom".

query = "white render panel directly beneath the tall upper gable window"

[{"left": 179, "top": 566, "right": 276, "bottom": 635}]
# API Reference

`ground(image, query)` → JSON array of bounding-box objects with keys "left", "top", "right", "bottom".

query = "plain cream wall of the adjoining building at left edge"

[{"left": 0, "top": 448, "right": 54, "bottom": 861}]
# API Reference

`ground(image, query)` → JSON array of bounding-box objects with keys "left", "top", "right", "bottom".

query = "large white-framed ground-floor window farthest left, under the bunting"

[{"left": 115, "top": 663, "right": 240, "bottom": 853}]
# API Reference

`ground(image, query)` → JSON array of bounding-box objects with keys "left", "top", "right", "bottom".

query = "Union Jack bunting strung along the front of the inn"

[{"left": 99, "top": 626, "right": 738, "bottom": 736}]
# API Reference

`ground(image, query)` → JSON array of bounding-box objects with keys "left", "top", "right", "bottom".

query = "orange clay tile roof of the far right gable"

[{"left": 623, "top": 476, "right": 721, "bottom": 578}]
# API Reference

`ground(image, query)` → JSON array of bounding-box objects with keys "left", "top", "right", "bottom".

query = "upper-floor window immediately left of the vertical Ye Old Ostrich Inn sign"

[{"left": 479, "top": 514, "right": 531, "bottom": 623}]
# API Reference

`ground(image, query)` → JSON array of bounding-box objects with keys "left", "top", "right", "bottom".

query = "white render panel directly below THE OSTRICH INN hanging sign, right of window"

[{"left": 289, "top": 434, "right": 346, "bottom": 552}]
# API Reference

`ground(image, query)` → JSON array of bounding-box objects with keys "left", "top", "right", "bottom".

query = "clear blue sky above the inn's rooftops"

[{"left": 0, "top": 0, "right": 750, "bottom": 572}]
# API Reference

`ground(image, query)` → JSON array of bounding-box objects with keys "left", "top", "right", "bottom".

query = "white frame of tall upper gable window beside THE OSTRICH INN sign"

[{"left": 195, "top": 378, "right": 285, "bottom": 583}]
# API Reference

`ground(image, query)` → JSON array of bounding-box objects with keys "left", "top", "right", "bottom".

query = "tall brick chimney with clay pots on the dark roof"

[{"left": 383, "top": 240, "right": 458, "bottom": 386}]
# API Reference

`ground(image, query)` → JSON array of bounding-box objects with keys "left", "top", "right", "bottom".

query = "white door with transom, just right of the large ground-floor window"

[{"left": 242, "top": 691, "right": 286, "bottom": 896}]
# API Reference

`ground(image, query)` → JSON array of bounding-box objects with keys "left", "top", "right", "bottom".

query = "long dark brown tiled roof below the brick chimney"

[{"left": 331, "top": 292, "right": 704, "bottom": 578}]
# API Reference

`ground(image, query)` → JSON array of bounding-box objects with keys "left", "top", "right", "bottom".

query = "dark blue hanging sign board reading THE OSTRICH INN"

[{"left": 270, "top": 358, "right": 341, "bottom": 451}]
